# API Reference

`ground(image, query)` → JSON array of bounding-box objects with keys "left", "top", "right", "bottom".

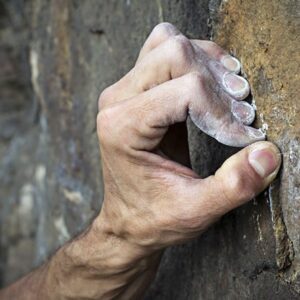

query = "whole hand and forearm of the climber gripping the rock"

[{"left": 0, "top": 23, "right": 281, "bottom": 300}]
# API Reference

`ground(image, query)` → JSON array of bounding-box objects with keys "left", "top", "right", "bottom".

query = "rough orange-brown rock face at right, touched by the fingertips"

[{"left": 214, "top": 0, "right": 300, "bottom": 294}]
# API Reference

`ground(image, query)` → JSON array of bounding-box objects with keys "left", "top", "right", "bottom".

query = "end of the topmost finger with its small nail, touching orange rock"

[{"left": 192, "top": 40, "right": 241, "bottom": 74}]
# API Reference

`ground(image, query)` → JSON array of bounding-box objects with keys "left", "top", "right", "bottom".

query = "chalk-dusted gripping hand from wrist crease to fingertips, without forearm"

[{"left": 98, "top": 24, "right": 280, "bottom": 254}]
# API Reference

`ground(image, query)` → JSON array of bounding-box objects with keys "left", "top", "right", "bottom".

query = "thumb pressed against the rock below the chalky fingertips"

[{"left": 191, "top": 142, "right": 281, "bottom": 216}]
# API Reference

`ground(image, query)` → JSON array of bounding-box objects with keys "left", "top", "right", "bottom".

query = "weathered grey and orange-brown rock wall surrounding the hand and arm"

[{"left": 0, "top": 0, "right": 300, "bottom": 300}]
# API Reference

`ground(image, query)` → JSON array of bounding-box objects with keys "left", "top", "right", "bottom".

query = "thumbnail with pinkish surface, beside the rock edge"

[{"left": 248, "top": 145, "right": 280, "bottom": 178}]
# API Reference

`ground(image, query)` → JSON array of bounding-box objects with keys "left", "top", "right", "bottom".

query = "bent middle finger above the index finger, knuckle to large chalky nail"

[{"left": 102, "top": 35, "right": 250, "bottom": 111}]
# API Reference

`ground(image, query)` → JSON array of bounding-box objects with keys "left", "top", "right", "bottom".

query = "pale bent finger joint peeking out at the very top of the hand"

[{"left": 136, "top": 22, "right": 181, "bottom": 64}]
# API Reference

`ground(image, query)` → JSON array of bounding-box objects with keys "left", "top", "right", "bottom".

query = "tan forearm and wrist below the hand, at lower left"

[{"left": 0, "top": 218, "right": 161, "bottom": 300}]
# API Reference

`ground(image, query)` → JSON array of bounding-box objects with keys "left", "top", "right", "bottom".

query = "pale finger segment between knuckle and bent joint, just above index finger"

[{"left": 99, "top": 35, "right": 196, "bottom": 110}]
